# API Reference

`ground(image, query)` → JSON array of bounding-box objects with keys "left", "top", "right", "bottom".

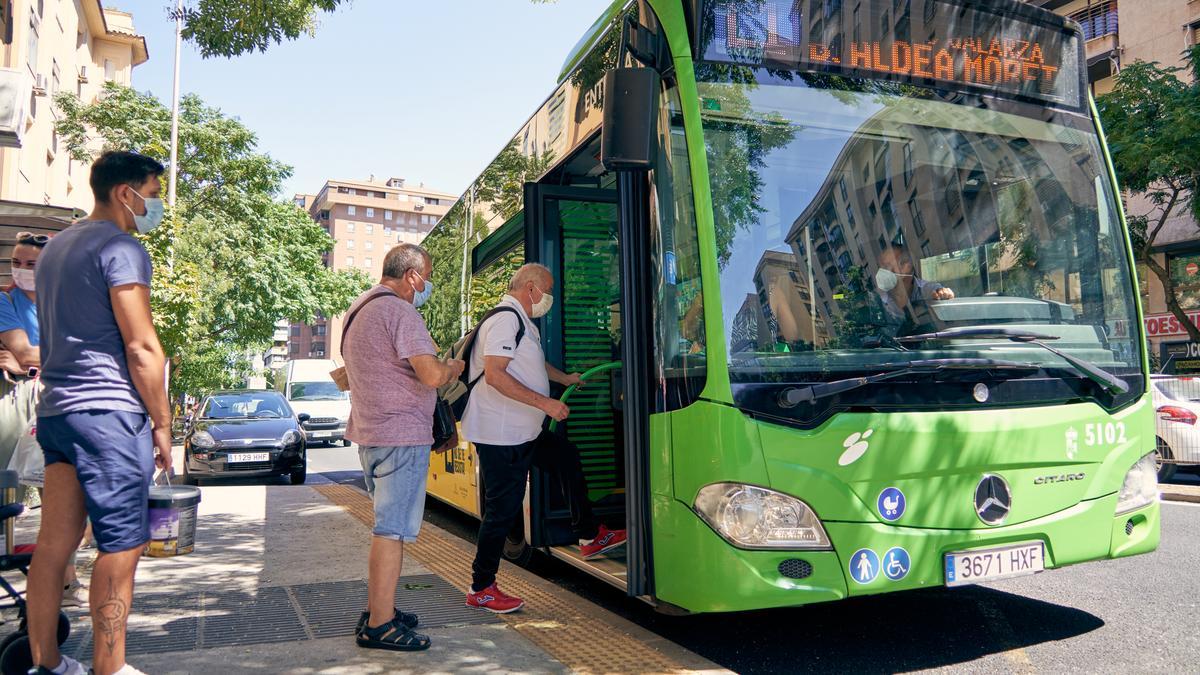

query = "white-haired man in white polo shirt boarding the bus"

[{"left": 462, "top": 263, "right": 609, "bottom": 614}]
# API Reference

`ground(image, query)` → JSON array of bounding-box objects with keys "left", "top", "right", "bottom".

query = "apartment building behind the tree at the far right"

[{"left": 1031, "top": 0, "right": 1200, "bottom": 372}]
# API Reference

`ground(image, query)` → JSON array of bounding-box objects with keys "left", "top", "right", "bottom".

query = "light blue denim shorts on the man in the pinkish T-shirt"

[{"left": 359, "top": 446, "right": 430, "bottom": 542}]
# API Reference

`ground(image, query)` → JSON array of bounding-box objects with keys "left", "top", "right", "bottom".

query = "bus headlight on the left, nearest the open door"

[{"left": 695, "top": 483, "right": 830, "bottom": 550}]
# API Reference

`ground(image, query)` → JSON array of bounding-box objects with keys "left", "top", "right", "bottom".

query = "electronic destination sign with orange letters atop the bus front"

[{"left": 704, "top": 0, "right": 1081, "bottom": 107}]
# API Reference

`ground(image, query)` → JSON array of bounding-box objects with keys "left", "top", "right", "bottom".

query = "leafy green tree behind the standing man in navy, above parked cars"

[{"left": 55, "top": 83, "right": 370, "bottom": 393}]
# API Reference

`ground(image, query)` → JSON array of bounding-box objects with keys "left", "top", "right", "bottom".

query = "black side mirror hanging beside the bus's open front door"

[{"left": 600, "top": 68, "right": 661, "bottom": 171}]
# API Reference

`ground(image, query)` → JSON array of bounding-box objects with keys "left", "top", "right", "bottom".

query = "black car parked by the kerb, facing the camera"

[{"left": 182, "top": 390, "right": 308, "bottom": 485}]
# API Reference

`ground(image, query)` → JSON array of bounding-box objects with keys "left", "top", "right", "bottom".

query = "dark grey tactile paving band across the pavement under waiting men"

[{"left": 42, "top": 574, "right": 499, "bottom": 661}]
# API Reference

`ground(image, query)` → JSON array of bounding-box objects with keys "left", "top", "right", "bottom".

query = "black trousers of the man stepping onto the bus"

[{"left": 470, "top": 431, "right": 599, "bottom": 590}]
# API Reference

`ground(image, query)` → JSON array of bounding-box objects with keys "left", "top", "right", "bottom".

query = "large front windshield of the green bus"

[{"left": 697, "top": 64, "right": 1141, "bottom": 413}]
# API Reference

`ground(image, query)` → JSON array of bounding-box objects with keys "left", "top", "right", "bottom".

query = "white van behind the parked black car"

[{"left": 283, "top": 359, "right": 350, "bottom": 447}]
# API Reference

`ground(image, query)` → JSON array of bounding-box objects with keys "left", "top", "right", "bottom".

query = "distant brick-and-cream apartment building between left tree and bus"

[{"left": 288, "top": 177, "right": 457, "bottom": 359}]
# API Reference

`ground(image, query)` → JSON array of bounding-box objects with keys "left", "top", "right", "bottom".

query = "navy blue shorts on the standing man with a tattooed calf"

[{"left": 37, "top": 411, "right": 154, "bottom": 552}]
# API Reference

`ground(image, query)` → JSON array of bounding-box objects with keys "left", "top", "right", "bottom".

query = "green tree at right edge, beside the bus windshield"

[{"left": 1096, "top": 46, "right": 1200, "bottom": 342}]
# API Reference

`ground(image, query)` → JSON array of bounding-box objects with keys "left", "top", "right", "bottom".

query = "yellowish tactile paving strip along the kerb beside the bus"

[{"left": 313, "top": 485, "right": 690, "bottom": 673}]
